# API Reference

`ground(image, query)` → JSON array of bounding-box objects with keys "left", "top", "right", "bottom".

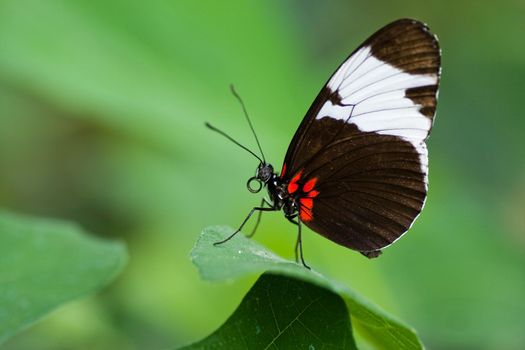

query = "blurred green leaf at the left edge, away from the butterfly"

[{"left": 0, "top": 211, "right": 127, "bottom": 344}]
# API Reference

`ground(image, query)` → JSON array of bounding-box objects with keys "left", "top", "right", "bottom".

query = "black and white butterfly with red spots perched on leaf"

[{"left": 208, "top": 19, "right": 441, "bottom": 267}]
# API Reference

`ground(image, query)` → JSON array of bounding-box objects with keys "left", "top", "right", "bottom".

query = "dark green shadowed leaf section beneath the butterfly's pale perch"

[{"left": 183, "top": 273, "right": 357, "bottom": 350}]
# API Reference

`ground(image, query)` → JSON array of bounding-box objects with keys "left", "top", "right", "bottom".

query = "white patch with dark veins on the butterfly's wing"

[{"left": 316, "top": 46, "right": 438, "bottom": 175}]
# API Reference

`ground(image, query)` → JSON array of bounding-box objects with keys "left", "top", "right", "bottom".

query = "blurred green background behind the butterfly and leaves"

[{"left": 0, "top": 0, "right": 525, "bottom": 349}]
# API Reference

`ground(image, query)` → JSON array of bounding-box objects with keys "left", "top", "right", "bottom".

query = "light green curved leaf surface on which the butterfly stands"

[{"left": 187, "top": 227, "right": 423, "bottom": 349}]
